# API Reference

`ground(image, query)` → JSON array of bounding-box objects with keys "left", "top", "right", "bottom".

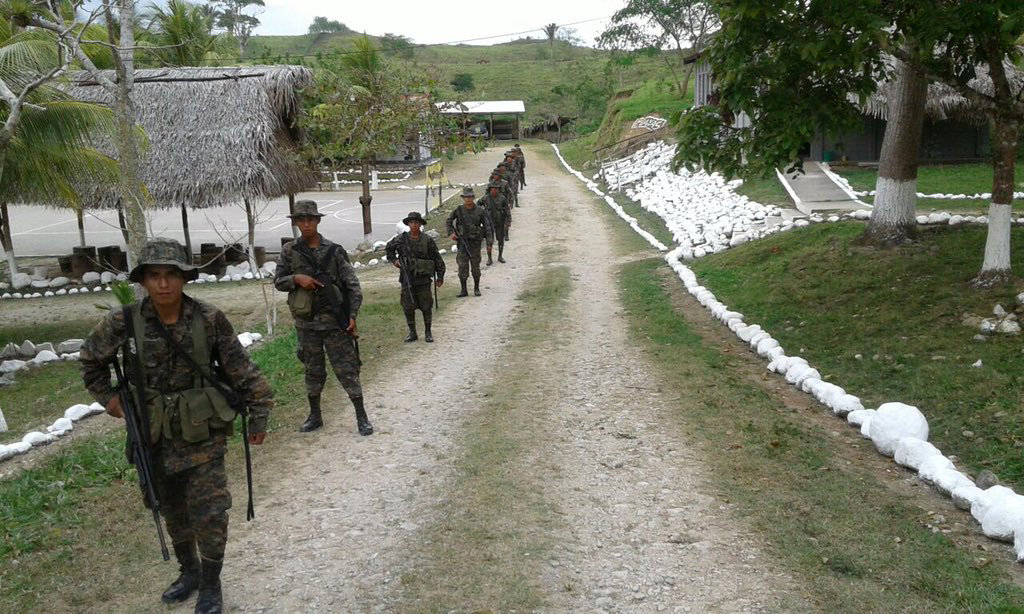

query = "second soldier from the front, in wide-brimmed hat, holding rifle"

[{"left": 273, "top": 201, "right": 374, "bottom": 435}]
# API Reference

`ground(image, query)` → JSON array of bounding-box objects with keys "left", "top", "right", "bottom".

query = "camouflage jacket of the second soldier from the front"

[{"left": 273, "top": 236, "right": 362, "bottom": 331}]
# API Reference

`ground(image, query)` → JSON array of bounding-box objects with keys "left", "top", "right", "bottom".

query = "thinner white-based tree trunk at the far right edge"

[{"left": 973, "top": 117, "right": 1020, "bottom": 288}]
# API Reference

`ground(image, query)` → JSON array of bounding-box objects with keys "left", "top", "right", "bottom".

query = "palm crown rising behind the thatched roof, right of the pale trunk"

[{"left": 142, "top": 0, "right": 227, "bottom": 67}]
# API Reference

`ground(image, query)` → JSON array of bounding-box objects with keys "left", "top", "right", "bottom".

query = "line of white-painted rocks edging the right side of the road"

[{"left": 552, "top": 145, "right": 1024, "bottom": 562}]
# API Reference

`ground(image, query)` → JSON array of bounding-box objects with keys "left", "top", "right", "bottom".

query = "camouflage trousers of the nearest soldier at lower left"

[{"left": 154, "top": 456, "right": 231, "bottom": 561}]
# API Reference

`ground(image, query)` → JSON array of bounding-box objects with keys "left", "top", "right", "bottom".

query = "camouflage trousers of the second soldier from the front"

[{"left": 296, "top": 328, "right": 362, "bottom": 398}]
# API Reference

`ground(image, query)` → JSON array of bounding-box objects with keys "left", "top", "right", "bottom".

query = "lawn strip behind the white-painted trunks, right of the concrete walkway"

[{"left": 833, "top": 162, "right": 1024, "bottom": 212}]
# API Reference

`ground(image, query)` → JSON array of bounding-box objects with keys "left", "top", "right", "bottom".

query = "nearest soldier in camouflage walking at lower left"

[{"left": 80, "top": 238, "right": 273, "bottom": 614}]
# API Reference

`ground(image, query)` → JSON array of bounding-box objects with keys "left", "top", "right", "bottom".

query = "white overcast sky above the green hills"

[{"left": 256, "top": 0, "right": 626, "bottom": 45}]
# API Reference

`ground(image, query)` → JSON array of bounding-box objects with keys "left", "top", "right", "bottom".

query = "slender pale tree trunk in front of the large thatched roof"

[{"left": 115, "top": 0, "right": 146, "bottom": 268}]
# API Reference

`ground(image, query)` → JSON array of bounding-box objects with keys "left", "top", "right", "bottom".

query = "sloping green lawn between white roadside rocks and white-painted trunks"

[{"left": 692, "top": 222, "right": 1024, "bottom": 490}]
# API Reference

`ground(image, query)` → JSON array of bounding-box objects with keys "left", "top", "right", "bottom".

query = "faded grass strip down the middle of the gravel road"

[{"left": 399, "top": 264, "right": 571, "bottom": 612}]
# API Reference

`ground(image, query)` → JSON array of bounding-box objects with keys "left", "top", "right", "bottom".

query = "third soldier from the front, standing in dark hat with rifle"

[{"left": 386, "top": 211, "right": 444, "bottom": 343}]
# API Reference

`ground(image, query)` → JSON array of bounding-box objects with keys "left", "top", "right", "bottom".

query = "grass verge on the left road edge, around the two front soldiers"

[{"left": 0, "top": 276, "right": 417, "bottom": 612}]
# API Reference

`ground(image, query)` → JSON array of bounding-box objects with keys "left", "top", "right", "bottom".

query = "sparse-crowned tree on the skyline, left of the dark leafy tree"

[{"left": 597, "top": 0, "right": 720, "bottom": 96}]
